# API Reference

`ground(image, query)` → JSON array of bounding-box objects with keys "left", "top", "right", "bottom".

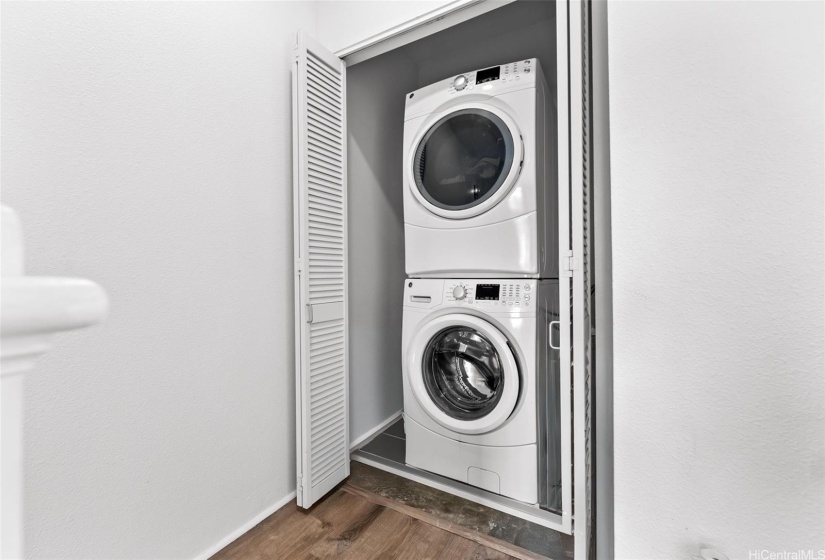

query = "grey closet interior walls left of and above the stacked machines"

[{"left": 347, "top": 1, "right": 556, "bottom": 442}]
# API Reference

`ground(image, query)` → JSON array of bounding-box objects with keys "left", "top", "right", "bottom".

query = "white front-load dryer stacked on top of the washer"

[{"left": 404, "top": 59, "right": 558, "bottom": 278}]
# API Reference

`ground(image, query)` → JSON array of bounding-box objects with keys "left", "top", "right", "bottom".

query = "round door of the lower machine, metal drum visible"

[{"left": 409, "top": 315, "right": 519, "bottom": 434}]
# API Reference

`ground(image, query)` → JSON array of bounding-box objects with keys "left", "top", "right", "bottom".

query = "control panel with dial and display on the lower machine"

[{"left": 444, "top": 280, "right": 536, "bottom": 311}]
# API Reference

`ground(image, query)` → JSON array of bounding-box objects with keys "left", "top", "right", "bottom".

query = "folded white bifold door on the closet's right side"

[{"left": 559, "top": 0, "right": 596, "bottom": 560}]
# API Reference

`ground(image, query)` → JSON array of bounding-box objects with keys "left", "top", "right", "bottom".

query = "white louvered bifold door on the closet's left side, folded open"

[{"left": 292, "top": 32, "right": 349, "bottom": 508}]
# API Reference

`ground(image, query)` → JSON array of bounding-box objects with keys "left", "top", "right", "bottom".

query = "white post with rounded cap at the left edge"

[{"left": 0, "top": 206, "right": 109, "bottom": 559}]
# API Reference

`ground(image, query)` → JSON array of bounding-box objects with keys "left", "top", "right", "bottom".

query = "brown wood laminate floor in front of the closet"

[{"left": 212, "top": 487, "right": 513, "bottom": 560}]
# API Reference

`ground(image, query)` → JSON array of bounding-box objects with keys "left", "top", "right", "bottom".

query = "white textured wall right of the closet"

[{"left": 608, "top": 2, "right": 825, "bottom": 559}]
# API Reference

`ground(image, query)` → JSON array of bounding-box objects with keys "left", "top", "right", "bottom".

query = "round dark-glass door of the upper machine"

[{"left": 412, "top": 104, "right": 523, "bottom": 218}]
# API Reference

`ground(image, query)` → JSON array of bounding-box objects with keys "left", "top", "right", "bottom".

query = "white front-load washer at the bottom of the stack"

[{"left": 402, "top": 278, "right": 561, "bottom": 510}]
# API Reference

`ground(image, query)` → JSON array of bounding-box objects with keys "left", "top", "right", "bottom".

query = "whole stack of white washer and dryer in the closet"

[{"left": 402, "top": 59, "right": 561, "bottom": 511}]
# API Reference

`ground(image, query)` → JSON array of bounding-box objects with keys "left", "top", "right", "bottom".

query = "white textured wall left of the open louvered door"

[{"left": 2, "top": 2, "right": 316, "bottom": 558}]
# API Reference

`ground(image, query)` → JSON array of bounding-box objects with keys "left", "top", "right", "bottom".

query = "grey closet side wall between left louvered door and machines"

[{"left": 347, "top": 51, "right": 418, "bottom": 441}]
